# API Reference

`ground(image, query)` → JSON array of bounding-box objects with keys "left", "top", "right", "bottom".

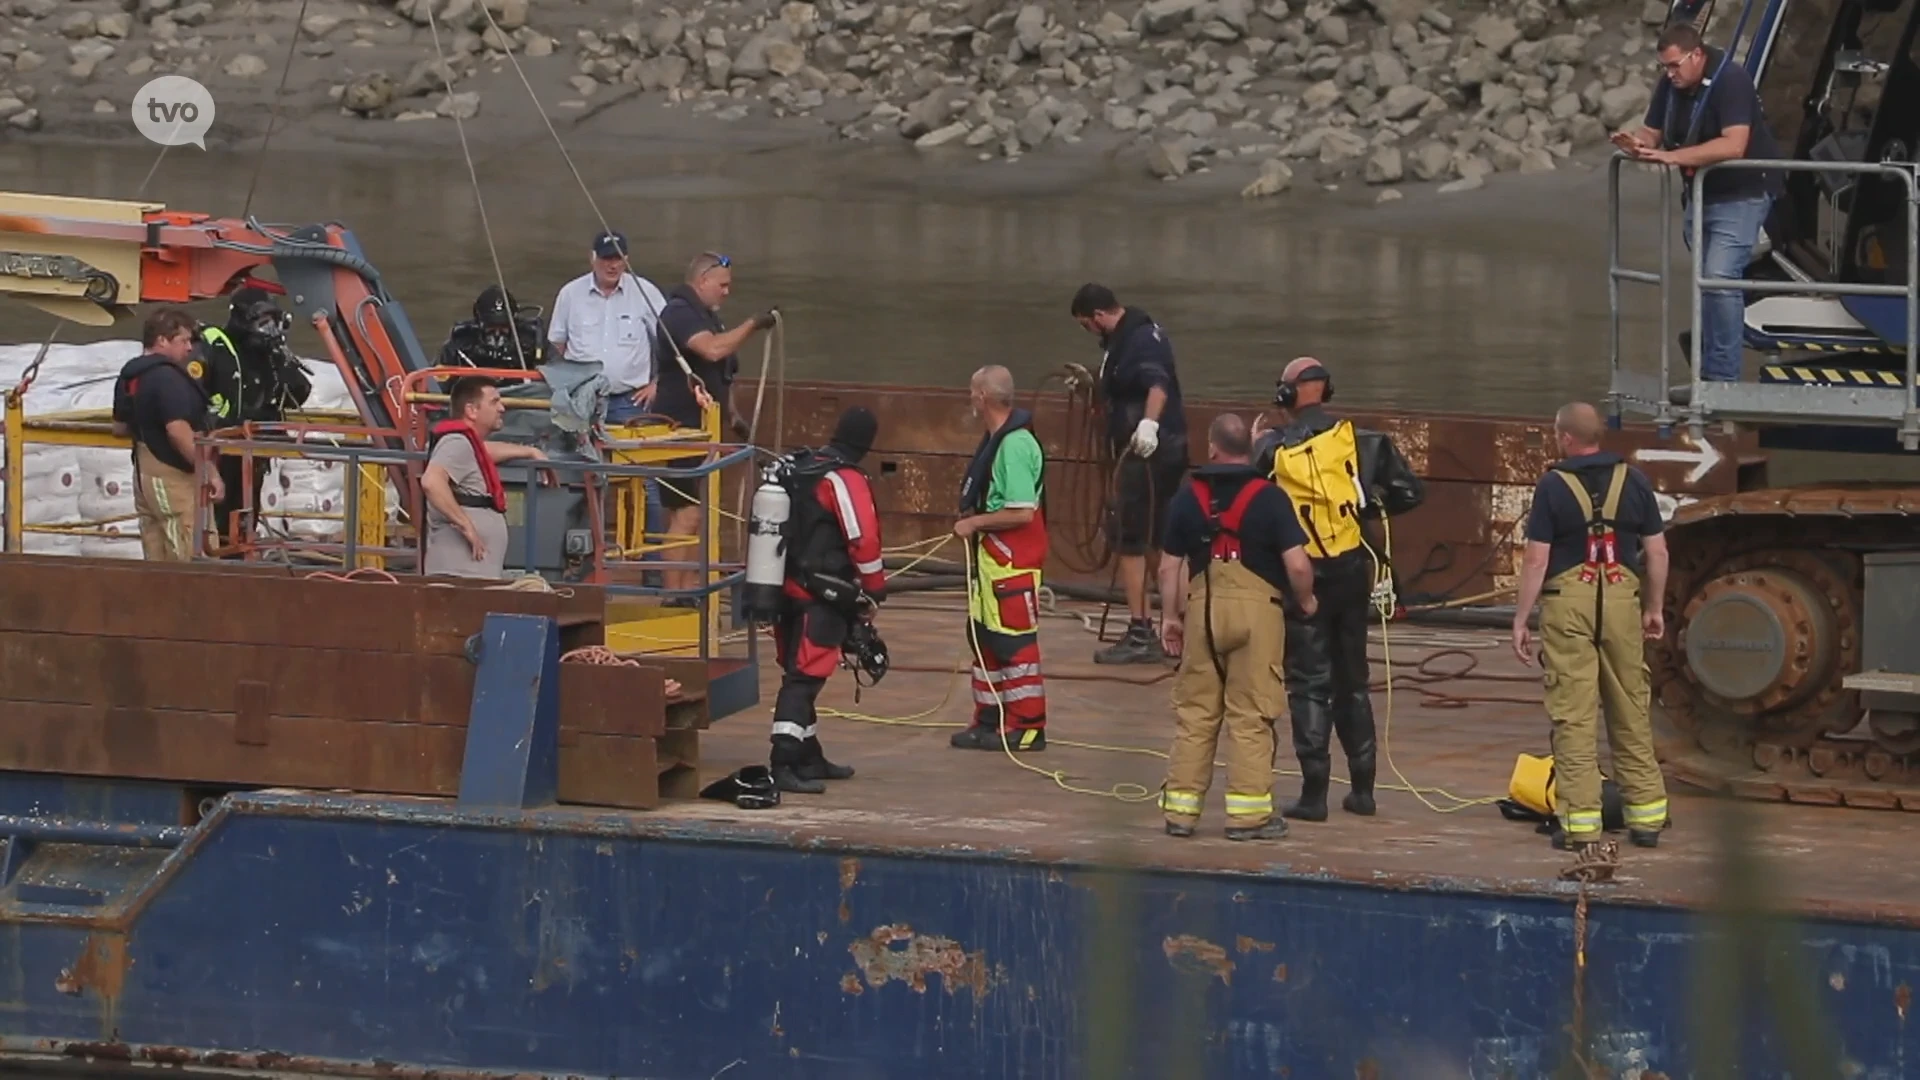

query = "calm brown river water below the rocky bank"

[{"left": 0, "top": 135, "right": 1684, "bottom": 415}]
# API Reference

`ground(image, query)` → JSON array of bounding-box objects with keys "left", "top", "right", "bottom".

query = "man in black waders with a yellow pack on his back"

[{"left": 1254, "top": 356, "right": 1427, "bottom": 821}]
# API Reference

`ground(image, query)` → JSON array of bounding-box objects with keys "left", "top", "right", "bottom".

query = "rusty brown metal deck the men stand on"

[{"left": 683, "top": 596, "right": 1920, "bottom": 926}]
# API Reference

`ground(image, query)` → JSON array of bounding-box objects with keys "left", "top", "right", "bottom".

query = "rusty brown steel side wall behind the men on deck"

[{"left": 728, "top": 380, "right": 1766, "bottom": 600}]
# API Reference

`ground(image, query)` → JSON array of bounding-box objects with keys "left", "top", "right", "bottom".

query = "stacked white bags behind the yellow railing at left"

[{"left": 0, "top": 340, "right": 399, "bottom": 559}]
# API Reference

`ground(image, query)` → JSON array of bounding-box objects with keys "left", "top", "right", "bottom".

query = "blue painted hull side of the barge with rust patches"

[{"left": 0, "top": 772, "right": 1920, "bottom": 1080}]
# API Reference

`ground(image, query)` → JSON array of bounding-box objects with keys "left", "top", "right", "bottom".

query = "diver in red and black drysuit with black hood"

[{"left": 768, "top": 405, "right": 887, "bottom": 796}]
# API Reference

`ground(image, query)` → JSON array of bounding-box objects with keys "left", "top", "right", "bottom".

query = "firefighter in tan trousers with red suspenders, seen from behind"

[{"left": 1160, "top": 413, "right": 1319, "bottom": 840}]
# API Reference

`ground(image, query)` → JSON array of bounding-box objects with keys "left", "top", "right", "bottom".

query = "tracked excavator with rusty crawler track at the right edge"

[{"left": 1609, "top": 0, "right": 1920, "bottom": 799}]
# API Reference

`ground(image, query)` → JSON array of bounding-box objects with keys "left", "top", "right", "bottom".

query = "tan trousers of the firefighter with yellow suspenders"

[{"left": 1540, "top": 567, "right": 1667, "bottom": 840}]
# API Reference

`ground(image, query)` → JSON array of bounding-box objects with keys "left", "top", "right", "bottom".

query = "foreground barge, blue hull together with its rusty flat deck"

[{"left": 0, "top": 611, "right": 1920, "bottom": 1080}]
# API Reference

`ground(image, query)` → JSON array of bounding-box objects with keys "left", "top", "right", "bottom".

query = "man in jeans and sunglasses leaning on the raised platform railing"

[{"left": 1613, "top": 23, "right": 1780, "bottom": 382}]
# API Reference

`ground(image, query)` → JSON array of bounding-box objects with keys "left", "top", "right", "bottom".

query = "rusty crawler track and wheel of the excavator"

[{"left": 1647, "top": 484, "right": 1920, "bottom": 811}]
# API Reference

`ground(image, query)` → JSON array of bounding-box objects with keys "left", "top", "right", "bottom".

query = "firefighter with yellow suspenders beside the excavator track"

[{"left": 1513, "top": 404, "right": 1667, "bottom": 851}]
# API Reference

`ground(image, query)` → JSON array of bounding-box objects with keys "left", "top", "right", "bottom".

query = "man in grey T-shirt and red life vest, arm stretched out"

[{"left": 420, "top": 377, "right": 547, "bottom": 578}]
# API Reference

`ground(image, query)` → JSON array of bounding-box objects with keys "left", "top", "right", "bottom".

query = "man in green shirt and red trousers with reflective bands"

[{"left": 950, "top": 365, "right": 1046, "bottom": 751}]
